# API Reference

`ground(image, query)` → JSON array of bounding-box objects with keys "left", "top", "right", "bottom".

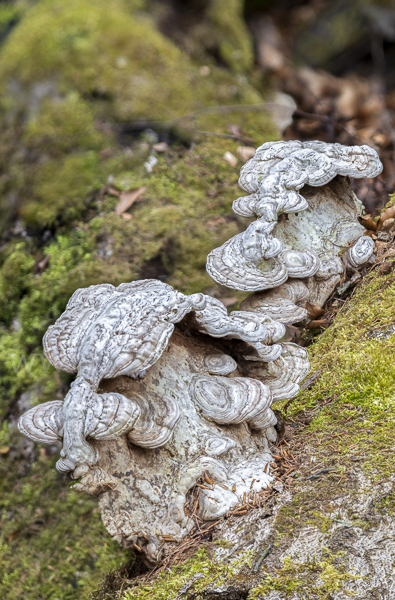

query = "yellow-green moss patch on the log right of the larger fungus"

[{"left": 291, "top": 264, "right": 395, "bottom": 478}]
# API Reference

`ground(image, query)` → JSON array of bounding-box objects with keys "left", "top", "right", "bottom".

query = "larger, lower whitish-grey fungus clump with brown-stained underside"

[{"left": 19, "top": 280, "right": 308, "bottom": 562}]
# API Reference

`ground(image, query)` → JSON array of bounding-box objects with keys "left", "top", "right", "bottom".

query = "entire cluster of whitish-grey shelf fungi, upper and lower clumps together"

[{"left": 19, "top": 141, "right": 382, "bottom": 564}]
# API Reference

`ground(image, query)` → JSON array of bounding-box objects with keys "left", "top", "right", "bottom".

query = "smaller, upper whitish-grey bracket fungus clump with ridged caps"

[{"left": 207, "top": 141, "right": 382, "bottom": 306}]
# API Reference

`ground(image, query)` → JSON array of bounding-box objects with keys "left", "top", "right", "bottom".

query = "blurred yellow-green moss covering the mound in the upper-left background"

[{"left": 0, "top": 0, "right": 267, "bottom": 227}]
